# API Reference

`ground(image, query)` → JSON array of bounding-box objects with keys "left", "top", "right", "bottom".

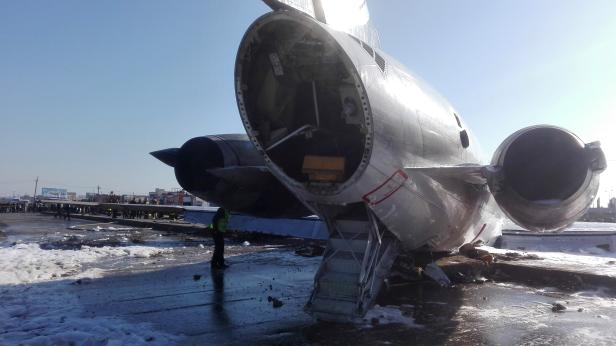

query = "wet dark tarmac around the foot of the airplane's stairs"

[{"left": 0, "top": 214, "right": 616, "bottom": 345}]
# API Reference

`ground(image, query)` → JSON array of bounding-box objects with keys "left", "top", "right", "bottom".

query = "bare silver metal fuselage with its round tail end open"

[{"left": 236, "top": 11, "right": 504, "bottom": 250}]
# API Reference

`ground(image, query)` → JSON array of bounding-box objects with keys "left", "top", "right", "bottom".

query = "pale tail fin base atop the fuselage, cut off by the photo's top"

[{"left": 263, "top": 0, "right": 380, "bottom": 48}]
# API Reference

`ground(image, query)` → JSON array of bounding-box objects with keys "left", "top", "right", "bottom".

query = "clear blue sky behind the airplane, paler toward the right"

[{"left": 0, "top": 0, "right": 616, "bottom": 203}]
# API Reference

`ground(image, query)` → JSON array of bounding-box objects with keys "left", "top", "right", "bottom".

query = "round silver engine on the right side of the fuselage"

[{"left": 489, "top": 125, "right": 607, "bottom": 231}]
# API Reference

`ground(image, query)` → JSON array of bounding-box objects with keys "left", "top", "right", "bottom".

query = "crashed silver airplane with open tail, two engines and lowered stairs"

[{"left": 152, "top": 0, "right": 606, "bottom": 321}]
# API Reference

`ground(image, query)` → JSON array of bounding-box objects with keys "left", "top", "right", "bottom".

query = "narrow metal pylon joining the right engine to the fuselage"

[{"left": 404, "top": 164, "right": 496, "bottom": 185}]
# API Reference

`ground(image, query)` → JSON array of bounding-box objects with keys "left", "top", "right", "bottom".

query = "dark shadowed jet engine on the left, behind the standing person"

[{"left": 151, "top": 134, "right": 311, "bottom": 217}]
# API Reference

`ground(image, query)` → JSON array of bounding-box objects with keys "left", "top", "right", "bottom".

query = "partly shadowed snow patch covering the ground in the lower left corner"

[{"left": 0, "top": 244, "right": 179, "bottom": 345}]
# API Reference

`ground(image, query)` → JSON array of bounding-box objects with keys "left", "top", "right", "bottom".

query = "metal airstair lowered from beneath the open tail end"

[{"left": 306, "top": 210, "right": 398, "bottom": 322}]
